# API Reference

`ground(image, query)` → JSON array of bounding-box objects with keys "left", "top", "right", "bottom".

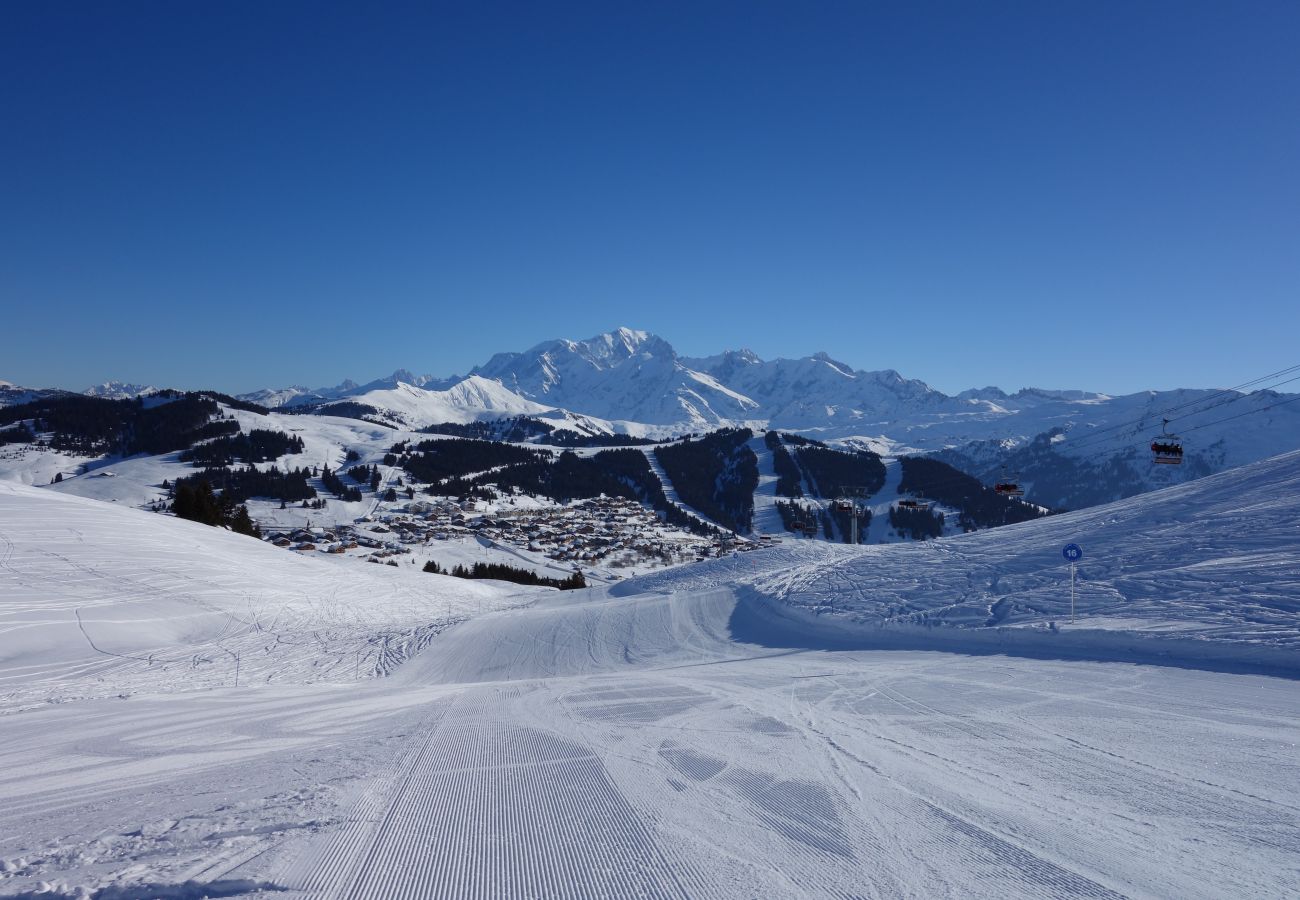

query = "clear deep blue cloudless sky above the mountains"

[{"left": 0, "top": 0, "right": 1300, "bottom": 393}]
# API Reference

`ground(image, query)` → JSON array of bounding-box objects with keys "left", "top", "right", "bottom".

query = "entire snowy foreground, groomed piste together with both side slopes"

[{"left": 0, "top": 453, "right": 1300, "bottom": 900}]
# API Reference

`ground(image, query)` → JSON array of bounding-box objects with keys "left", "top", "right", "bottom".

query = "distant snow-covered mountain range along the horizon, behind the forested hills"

[{"left": 0, "top": 328, "right": 1300, "bottom": 509}]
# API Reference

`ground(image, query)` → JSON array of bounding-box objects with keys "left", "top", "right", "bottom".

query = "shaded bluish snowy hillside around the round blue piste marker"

[{"left": 631, "top": 451, "right": 1300, "bottom": 674}]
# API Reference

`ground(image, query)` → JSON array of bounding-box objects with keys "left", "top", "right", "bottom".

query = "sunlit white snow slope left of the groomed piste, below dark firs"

[{"left": 0, "top": 481, "right": 525, "bottom": 711}]
